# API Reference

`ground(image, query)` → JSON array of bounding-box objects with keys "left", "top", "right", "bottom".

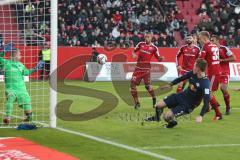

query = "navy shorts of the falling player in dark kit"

[{"left": 163, "top": 93, "right": 192, "bottom": 116}]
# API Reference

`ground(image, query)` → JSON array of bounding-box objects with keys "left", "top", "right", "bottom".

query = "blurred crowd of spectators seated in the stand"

[{"left": 10, "top": 0, "right": 240, "bottom": 48}]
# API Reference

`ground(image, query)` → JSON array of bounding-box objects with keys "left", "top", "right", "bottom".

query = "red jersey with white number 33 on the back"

[{"left": 200, "top": 42, "right": 221, "bottom": 76}]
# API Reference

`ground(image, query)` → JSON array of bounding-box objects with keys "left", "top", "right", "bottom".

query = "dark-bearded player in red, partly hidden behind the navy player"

[{"left": 176, "top": 35, "right": 200, "bottom": 93}]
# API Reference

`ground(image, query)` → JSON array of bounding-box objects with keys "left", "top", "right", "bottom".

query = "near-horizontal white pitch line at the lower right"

[{"left": 141, "top": 144, "right": 240, "bottom": 150}]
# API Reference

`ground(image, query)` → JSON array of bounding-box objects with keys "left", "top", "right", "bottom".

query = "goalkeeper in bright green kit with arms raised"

[{"left": 0, "top": 43, "right": 44, "bottom": 124}]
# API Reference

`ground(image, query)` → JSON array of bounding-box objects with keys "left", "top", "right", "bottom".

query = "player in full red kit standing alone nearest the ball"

[{"left": 131, "top": 34, "right": 163, "bottom": 109}]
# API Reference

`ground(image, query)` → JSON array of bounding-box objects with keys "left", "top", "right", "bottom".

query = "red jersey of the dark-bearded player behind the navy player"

[{"left": 176, "top": 45, "right": 200, "bottom": 71}]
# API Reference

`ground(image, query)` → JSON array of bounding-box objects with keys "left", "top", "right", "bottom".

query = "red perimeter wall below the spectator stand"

[{"left": 12, "top": 46, "right": 240, "bottom": 79}]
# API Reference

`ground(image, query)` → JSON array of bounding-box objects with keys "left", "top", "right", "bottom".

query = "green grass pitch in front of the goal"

[{"left": 0, "top": 81, "right": 240, "bottom": 160}]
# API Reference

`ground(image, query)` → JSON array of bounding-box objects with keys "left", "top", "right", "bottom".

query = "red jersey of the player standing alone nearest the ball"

[{"left": 134, "top": 42, "right": 160, "bottom": 69}]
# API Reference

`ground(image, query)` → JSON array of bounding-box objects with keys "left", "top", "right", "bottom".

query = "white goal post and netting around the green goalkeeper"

[{"left": 0, "top": 0, "right": 58, "bottom": 128}]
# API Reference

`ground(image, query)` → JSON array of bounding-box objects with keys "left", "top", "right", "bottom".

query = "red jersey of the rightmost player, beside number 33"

[{"left": 219, "top": 45, "right": 233, "bottom": 75}]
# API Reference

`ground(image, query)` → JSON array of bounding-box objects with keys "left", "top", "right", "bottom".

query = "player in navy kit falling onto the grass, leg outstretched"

[{"left": 146, "top": 59, "right": 210, "bottom": 128}]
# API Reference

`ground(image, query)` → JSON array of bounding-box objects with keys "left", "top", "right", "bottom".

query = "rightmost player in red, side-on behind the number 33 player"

[{"left": 211, "top": 35, "right": 236, "bottom": 115}]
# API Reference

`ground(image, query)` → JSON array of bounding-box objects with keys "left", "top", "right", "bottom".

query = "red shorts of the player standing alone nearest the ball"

[{"left": 131, "top": 68, "right": 151, "bottom": 85}]
